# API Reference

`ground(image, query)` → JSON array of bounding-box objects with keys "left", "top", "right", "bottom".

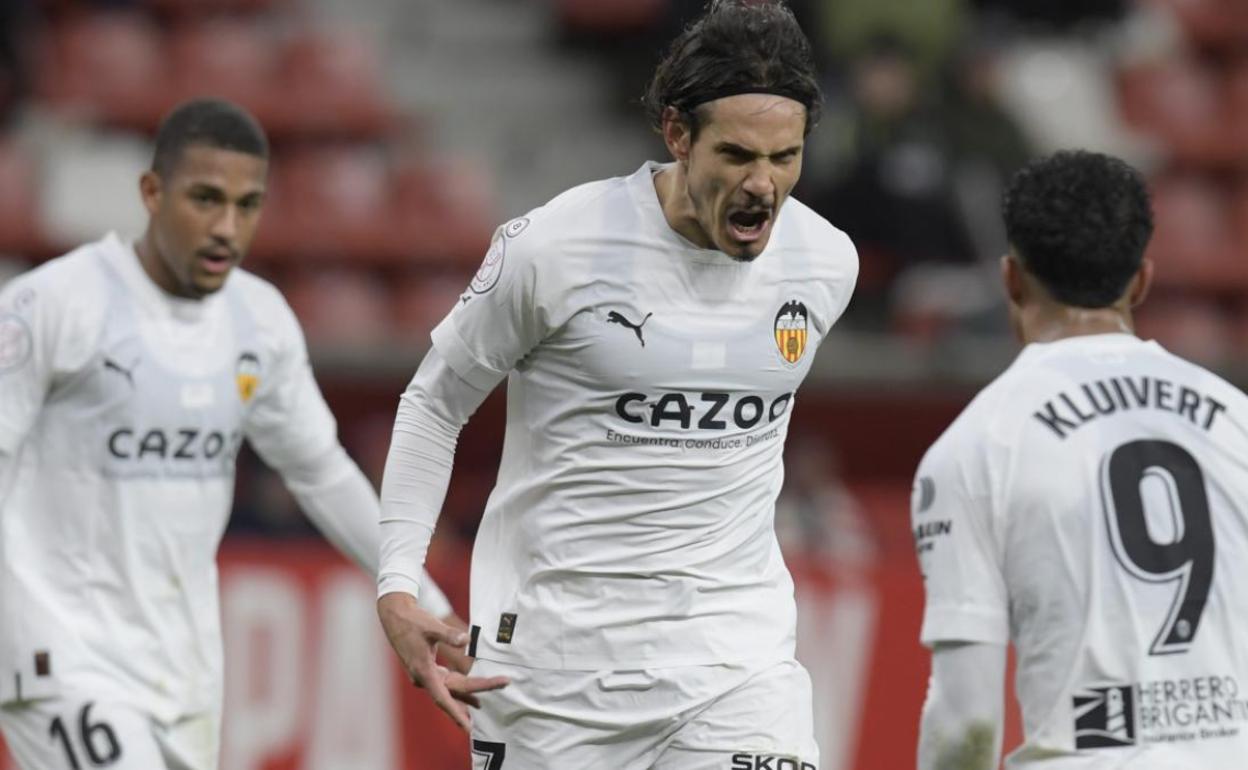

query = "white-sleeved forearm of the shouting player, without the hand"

[{"left": 378, "top": 351, "right": 487, "bottom": 595}]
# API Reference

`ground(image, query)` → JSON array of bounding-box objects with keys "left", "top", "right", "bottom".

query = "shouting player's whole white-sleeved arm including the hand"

[{"left": 377, "top": 220, "right": 552, "bottom": 730}]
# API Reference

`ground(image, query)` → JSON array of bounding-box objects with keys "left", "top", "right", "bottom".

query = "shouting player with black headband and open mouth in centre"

[{"left": 378, "top": 0, "right": 857, "bottom": 770}]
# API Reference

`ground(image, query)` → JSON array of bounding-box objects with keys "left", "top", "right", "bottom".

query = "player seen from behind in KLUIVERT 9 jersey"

[{"left": 912, "top": 152, "right": 1248, "bottom": 770}]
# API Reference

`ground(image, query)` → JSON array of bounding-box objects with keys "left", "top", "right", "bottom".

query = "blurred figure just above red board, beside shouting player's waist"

[{"left": 776, "top": 437, "right": 880, "bottom": 569}]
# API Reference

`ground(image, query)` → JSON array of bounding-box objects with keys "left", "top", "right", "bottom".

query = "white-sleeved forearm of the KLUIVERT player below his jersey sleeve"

[{"left": 919, "top": 644, "right": 1006, "bottom": 770}]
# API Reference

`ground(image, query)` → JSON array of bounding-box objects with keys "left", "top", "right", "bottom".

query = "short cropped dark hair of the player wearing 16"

[{"left": 152, "top": 99, "right": 268, "bottom": 178}]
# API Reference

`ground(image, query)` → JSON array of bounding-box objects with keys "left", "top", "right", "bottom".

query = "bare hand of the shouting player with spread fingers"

[{"left": 377, "top": 593, "right": 508, "bottom": 733}]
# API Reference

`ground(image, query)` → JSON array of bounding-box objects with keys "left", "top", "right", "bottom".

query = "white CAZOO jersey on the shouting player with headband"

[{"left": 433, "top": 163, "right": 857, "bottom": 669}]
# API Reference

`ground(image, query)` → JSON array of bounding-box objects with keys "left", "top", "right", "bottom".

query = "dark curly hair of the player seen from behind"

[{"left": 1005, "top": 151, "right": 1153, "bottom": 307}]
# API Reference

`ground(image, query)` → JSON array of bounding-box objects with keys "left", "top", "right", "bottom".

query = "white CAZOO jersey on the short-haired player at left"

[{"left": 0, "top": 236, "right": 337, "bottom": 720}]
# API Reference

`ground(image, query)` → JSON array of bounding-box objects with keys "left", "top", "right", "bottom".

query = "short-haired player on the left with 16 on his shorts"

[{"left": 0, "top": 100, "right": 474, "bottom": 770}]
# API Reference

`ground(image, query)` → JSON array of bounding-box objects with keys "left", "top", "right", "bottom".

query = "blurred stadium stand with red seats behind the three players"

[{"left": 0, "top": 0, "right": 1248, "bottom": 770}]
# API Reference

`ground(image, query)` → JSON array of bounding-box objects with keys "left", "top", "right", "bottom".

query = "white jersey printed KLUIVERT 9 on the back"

[{"left": 912, "top": 334, "right": 1248, "bottom": 770}]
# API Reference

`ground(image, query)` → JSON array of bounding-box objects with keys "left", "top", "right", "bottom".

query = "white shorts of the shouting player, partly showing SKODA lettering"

[{"left": 472, "top": 660, "right": 819, "bottom": 770}]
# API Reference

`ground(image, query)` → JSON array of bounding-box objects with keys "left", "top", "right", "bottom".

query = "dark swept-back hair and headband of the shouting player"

[{"left": 641, "top": 0, "right": 824, "bottom": 140}]
